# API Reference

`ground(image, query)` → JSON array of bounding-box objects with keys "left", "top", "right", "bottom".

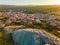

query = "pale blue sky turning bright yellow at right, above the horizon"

[{"left": 0, "top": 0, "right": 60, "bottom": 5}]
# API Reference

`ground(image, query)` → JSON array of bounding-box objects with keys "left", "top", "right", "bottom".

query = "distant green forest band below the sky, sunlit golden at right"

[{"left": 0, "top": 5, "right": 60, "bottom": 14}]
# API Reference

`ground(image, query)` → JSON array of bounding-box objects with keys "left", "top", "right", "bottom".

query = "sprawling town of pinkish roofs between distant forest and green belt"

[{"left": 0, "top": 11, "right": 60, "bottom": 28}]
